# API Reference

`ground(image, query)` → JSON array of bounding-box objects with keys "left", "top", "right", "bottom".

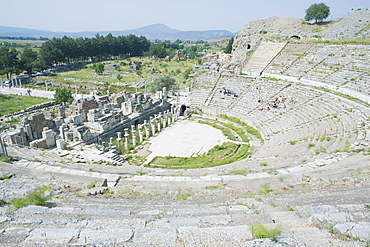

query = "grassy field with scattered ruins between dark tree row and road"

[{"left": 29, "top": 57, "right": 197, "bottom": 94}]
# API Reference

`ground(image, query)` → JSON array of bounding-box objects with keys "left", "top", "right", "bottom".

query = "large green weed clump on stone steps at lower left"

[{"left": 10, "top": 185, "right": 52, "bottom": 209}]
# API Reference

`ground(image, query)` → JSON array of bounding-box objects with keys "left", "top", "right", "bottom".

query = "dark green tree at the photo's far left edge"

[{"left": 0, "top": 46, "right": 20, "bottom": 79}]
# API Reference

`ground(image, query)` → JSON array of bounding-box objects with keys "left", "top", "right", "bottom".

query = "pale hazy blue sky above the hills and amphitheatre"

[{"left": 0, "top": 0, "right": 370, "bottom": 32}]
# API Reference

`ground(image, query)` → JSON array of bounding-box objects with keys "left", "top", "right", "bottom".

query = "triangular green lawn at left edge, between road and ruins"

[{"left": 0, "top": 94, "right": 50, "bottom": 115}]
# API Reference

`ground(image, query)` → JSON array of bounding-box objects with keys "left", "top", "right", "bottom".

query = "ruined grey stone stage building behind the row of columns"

[{"left": 4, "top": 91, "right": 175, "bottom": 149}]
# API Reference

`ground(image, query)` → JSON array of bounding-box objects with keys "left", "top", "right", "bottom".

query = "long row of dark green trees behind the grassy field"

[{"left": 0, "top": 34, "right": 150, "bottom": 79}]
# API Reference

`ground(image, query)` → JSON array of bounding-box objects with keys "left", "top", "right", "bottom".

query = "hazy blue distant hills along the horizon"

[{"left": 0, "top": 24, "right": 235, "bottom": 41}]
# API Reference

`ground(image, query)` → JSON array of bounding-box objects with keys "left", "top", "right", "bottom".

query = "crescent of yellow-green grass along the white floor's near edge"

[{"left": 147, "top": 142, "right": 250, "bottom": 169}]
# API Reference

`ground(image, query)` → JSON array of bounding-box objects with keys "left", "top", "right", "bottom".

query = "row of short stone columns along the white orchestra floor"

[{"left": 106, "top": 108, "right": 179, "bottom": 150}]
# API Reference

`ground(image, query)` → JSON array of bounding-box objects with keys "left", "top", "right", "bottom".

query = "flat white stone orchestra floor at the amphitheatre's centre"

[{"left": 146, "top": 120, "right": 228, "bottom": 162}]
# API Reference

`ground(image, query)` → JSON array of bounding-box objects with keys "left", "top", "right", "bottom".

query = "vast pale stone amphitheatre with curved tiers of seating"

[{"left": 0, "top": 10, "right": 370, "bottom": 246}]
